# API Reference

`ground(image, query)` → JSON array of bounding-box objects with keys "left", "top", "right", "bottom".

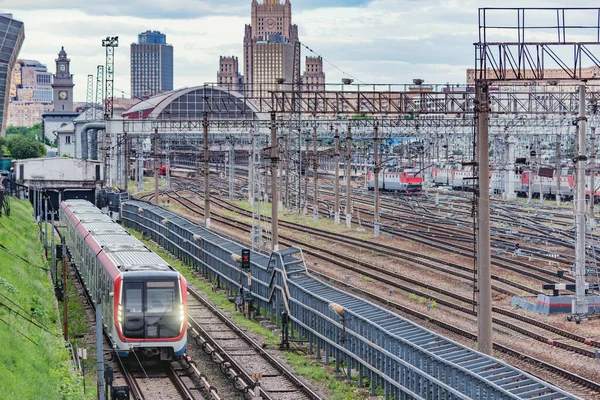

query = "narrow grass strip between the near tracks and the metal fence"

[{"left": 127, "top": 228, "right": 368, "bottom": 400}]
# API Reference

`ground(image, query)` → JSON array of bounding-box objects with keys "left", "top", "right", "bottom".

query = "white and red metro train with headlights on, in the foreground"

[{"left": 59, "top": 200, "right": 187, "bottom": 360}]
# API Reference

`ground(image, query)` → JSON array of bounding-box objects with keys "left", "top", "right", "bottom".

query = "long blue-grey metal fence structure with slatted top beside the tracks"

[{"left": 122, "top": 201, "right": 575, "bottom": 399}]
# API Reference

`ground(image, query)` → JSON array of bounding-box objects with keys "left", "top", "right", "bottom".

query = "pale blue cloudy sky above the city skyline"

[{"left": 5, "top": 0, "right": 597, "bottom": 101}]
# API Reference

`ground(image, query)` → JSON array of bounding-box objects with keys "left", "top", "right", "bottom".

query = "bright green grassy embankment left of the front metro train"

[{"left": 0, "top": 199, "right": 83, "bottom": 399}]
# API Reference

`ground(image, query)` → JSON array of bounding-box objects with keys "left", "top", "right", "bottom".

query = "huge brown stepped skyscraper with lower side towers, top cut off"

[{"left": 217, "top": 0, "right": 325, "bottom": 94}]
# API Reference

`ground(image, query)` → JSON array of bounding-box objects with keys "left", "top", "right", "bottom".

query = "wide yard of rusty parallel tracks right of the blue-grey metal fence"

[{"left": 110, "top": 166, "right": 600, "bottom": 398}]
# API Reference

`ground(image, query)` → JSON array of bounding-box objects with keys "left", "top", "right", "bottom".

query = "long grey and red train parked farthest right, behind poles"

[{"left": 432, "top": 167, "right": 600, "bottom": 202}]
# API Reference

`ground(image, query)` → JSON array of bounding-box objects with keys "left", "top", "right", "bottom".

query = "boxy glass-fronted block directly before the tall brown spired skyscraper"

[{"left": 252, "top": 33, "right": 294, "bottom": 97}]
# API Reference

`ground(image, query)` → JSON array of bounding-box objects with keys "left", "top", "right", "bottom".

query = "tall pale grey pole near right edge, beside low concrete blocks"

[{"left": 572, "top": 85, "right": 587, "bottom": 315}]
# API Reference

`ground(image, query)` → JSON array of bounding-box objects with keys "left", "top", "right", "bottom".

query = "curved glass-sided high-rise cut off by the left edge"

[{"left": 0, "top": 14, "right": 25, "bottom": 136}]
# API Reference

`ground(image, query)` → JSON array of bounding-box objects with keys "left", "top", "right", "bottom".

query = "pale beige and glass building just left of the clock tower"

[{"left": 7, "top": 60, "right": 52, "bottom": 127}]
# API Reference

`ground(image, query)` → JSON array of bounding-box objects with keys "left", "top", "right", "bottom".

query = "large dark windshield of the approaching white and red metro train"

[{"left": 123, "top": 280, "right": 181, "bottom": 339}]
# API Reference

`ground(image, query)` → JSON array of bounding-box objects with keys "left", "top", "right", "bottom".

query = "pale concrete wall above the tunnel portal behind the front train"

[{"left": 14, "top": 157, "right": 104, "bottom": 182}]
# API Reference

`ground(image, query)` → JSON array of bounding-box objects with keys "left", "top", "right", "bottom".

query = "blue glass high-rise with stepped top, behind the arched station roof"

[{"left": 131, "top": 31, "right": 173, "bottom": 99}]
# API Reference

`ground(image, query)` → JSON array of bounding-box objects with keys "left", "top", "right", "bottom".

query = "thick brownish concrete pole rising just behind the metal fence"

[{"left": 476, "top": 82, "right": 493, "bottom": 356}]
